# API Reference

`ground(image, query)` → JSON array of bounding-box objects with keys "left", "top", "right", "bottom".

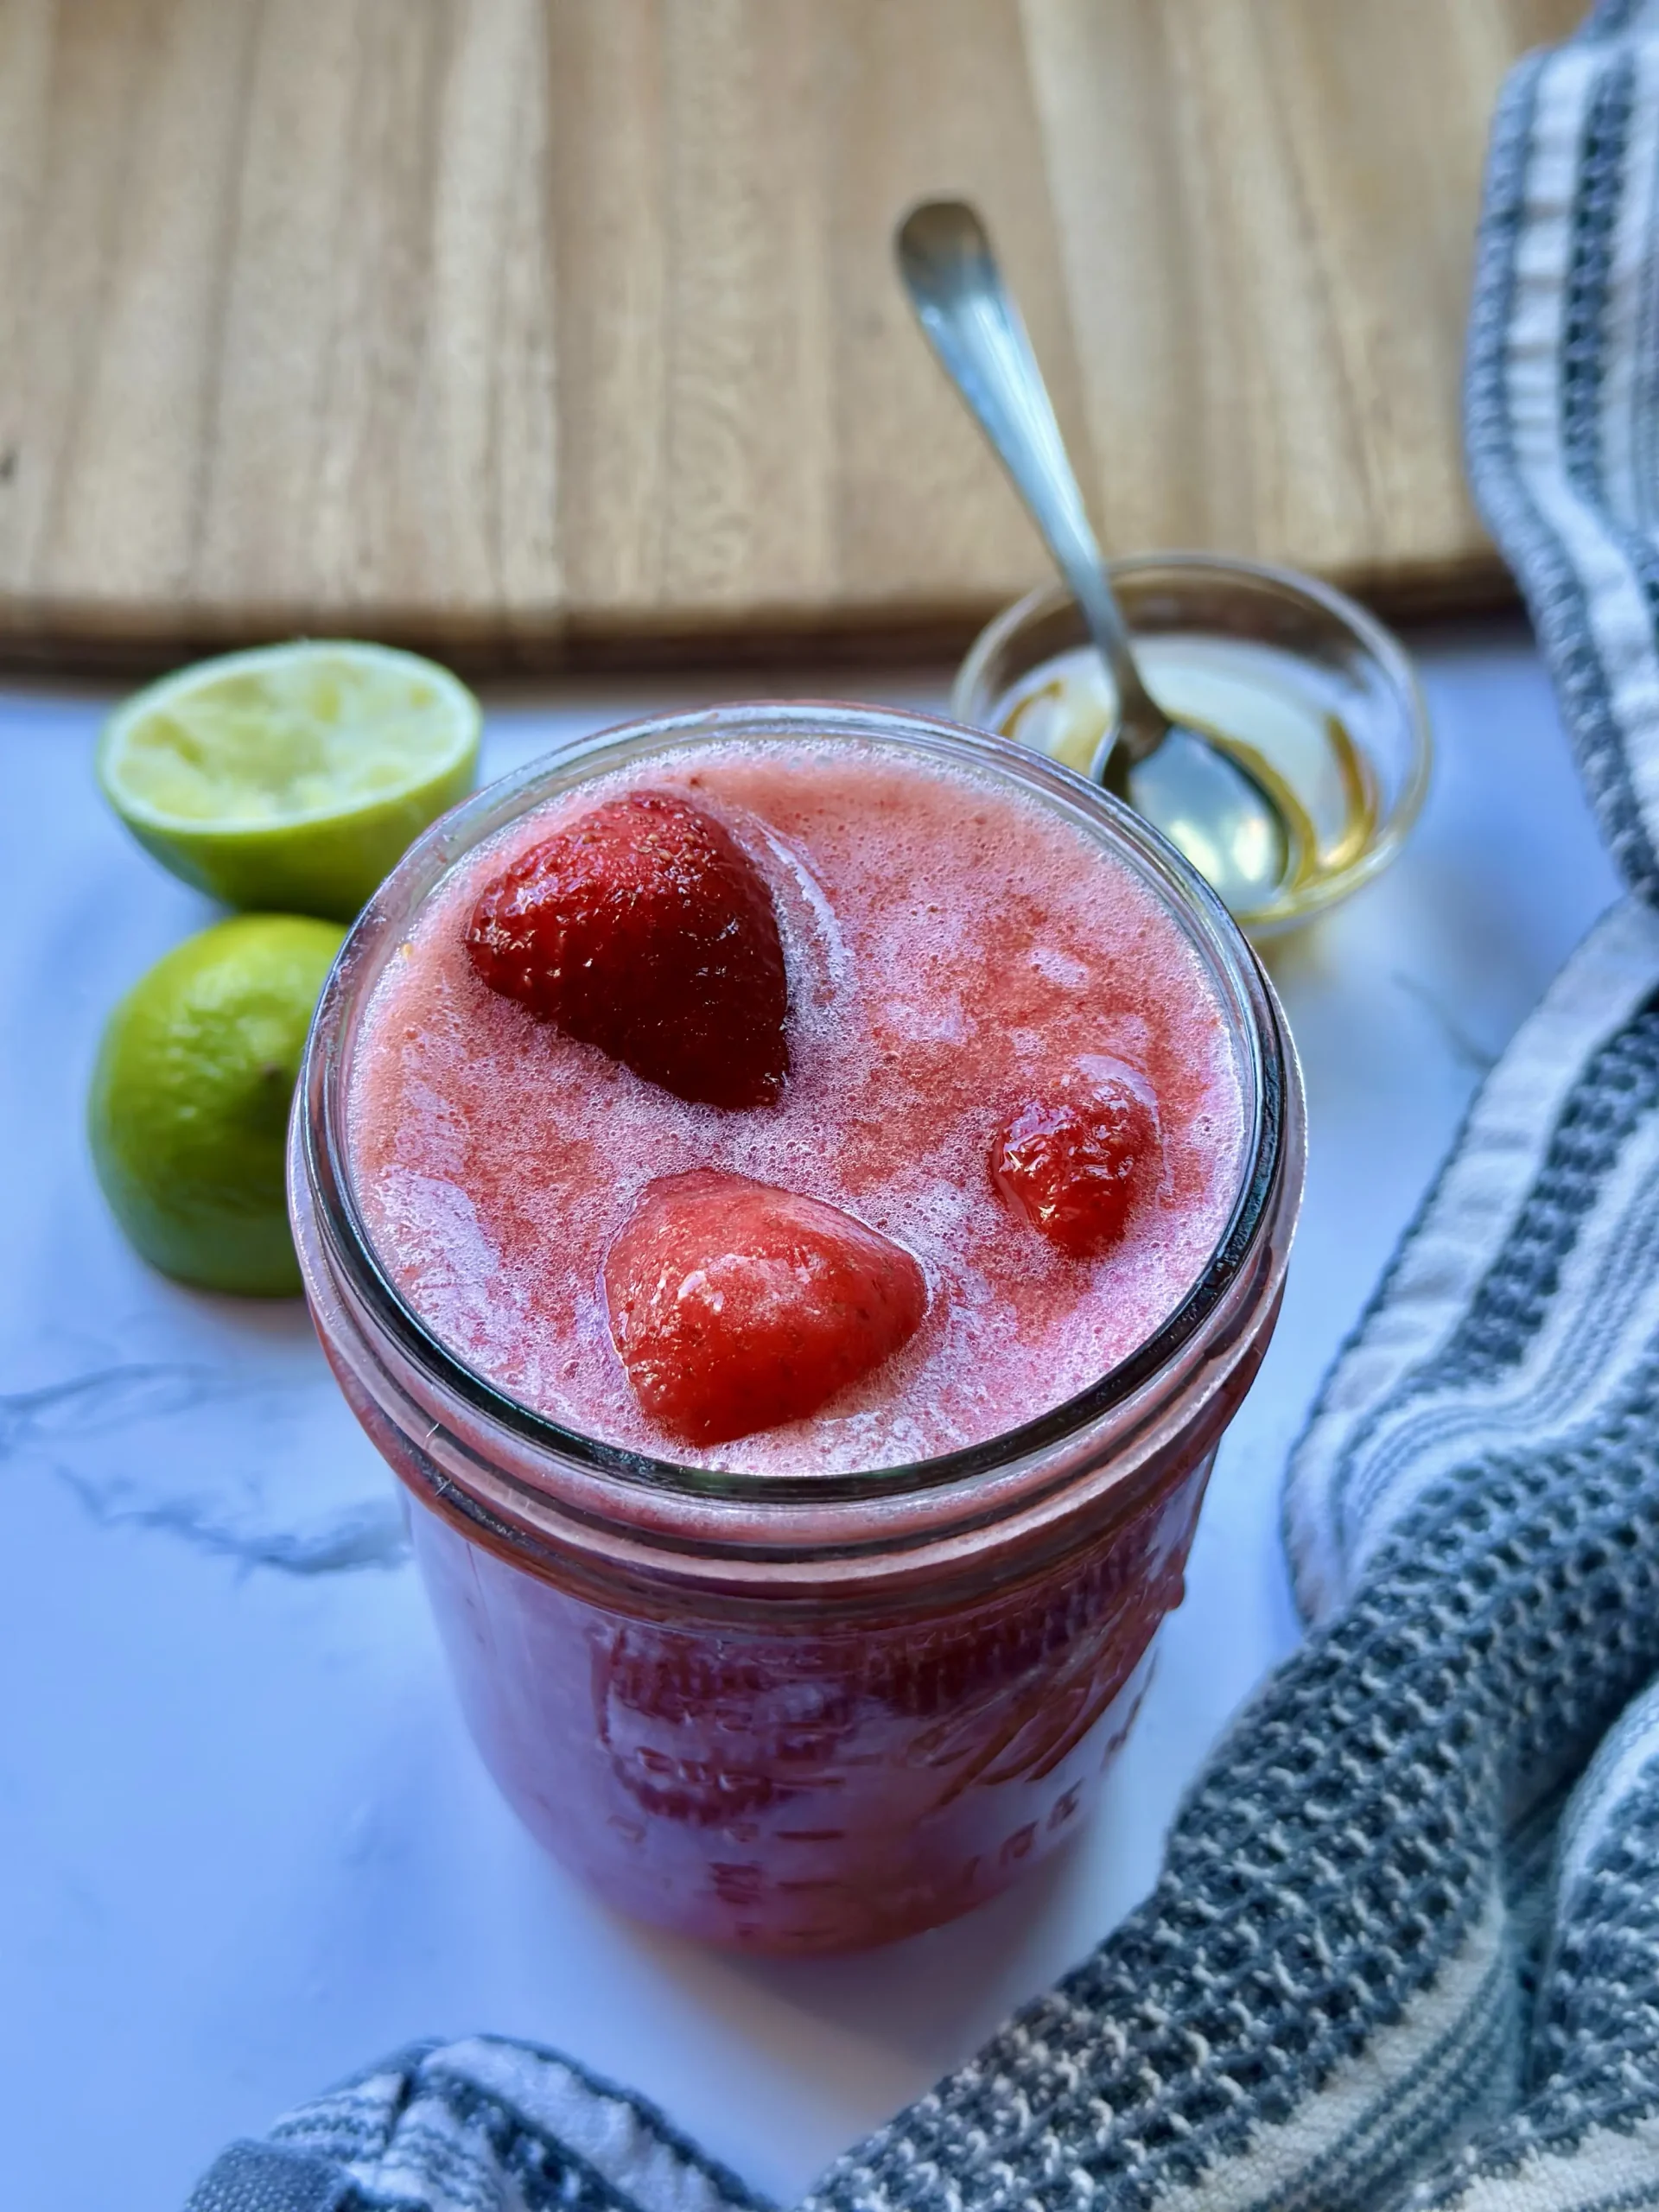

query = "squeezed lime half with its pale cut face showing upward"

[{"left": 98, "top": 641, "right": 480, "bottom": 923}]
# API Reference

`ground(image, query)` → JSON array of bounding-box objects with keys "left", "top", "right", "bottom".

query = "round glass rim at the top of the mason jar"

[{"left": 305, "top": 699, "right": 1299, "bottom": 1506}]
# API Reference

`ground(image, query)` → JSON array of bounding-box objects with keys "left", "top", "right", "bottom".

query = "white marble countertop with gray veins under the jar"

[{"left": 0, "top": 624, "right": 1615, "bottom": 2212}]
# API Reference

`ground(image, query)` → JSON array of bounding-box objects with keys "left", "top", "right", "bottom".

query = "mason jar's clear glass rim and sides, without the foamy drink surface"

[{"left": 289, "top": 703, "right": 1303, "bottom": 1951}]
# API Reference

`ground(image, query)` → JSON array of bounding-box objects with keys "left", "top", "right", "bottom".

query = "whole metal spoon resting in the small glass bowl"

[{"left": 893, "top": 199, "right": 1299, "bottom": 913}]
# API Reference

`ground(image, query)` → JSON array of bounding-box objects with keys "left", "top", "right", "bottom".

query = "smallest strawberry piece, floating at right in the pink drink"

[{"left": 991, "top": 1068, "right": 1164, "bottom": 1259}]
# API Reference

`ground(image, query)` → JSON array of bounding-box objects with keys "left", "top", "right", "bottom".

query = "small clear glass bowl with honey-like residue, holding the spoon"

[{"left": 951, "top": 553, "right": 1431, "bottom": 938}]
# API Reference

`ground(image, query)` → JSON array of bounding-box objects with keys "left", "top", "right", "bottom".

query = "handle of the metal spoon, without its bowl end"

[{"left": 896, "top": 199, "right": 1170, "bottom": 754}]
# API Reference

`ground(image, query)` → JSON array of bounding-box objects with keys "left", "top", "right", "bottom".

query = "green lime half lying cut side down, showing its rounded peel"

[{"left": 88, "top": 913, "right": 345, "bottom": 1296}]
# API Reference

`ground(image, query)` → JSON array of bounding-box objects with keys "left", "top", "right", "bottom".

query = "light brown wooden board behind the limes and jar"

[{"left": 0, "top": 0, "right": 1580, "bottom": 666}]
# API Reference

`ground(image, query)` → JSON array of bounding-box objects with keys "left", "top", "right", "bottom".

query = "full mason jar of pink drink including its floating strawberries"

[{"left": 294, "top": 708, "right": 1300, "bottom": 1948}]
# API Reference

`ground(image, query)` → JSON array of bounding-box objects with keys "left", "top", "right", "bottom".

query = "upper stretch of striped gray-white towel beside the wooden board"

[{"left": 1465, "top": 0, "right": 1659, "bottom": 902}]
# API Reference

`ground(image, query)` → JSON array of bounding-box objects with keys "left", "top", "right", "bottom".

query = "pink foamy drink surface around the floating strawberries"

[{"left": 349, "top": 741, "right": 1243, "bottom": 1471}]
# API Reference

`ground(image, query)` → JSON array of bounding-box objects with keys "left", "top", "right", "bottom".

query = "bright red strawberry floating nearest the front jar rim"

[{"left": 604, "top": 1168, "right": 927, "bottom": 1445}]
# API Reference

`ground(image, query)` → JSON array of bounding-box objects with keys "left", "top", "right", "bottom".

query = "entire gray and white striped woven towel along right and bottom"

[{"left": 190, "top": 0, "right": 1659, "bottom": 2212}]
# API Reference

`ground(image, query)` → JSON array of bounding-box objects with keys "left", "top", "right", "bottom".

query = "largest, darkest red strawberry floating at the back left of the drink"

[{"left": 467, "top": 791, "right": 790, "bottom": 1106}]
